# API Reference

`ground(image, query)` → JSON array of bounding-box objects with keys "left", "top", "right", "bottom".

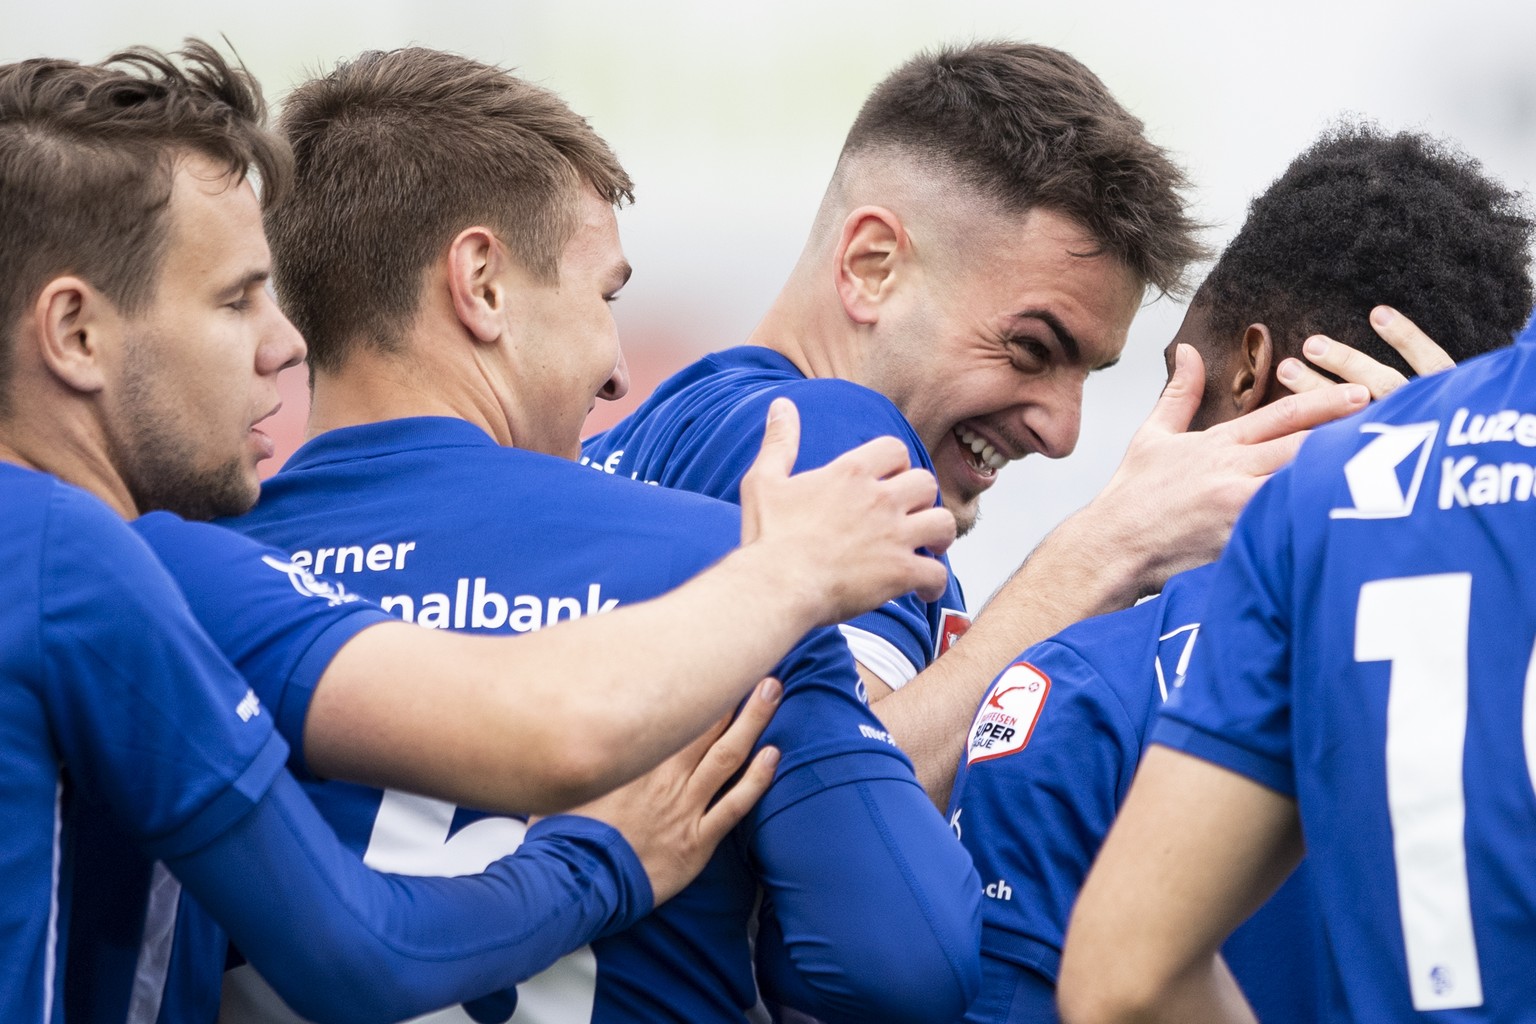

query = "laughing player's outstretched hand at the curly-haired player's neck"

[{"left": 1068, "top": 345, "right": 1370, "bottom": 599}]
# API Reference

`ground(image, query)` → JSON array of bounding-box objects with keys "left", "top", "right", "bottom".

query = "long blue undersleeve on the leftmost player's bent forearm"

[{"left": 167, "top": 774, "right": 651, "bottom": 1024}]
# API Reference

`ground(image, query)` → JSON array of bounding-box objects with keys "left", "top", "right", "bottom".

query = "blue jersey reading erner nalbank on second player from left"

[{"left": 224, "top": 418, "right": 980, "bottom": 1024}]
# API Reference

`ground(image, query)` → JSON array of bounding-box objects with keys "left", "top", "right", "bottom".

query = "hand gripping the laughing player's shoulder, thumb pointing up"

[{"left": 742, "top": 398, "right": 955, "bottom": 625}]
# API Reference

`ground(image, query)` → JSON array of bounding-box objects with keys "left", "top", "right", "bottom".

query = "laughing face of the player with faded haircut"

[{"left": 877, "top": 210, "right": 1143, "bottom": 533}]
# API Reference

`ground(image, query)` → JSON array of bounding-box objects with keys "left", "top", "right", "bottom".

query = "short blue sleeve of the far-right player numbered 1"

[{"left": 1152, "top": 468, "right": 1296, "bottom": 797}]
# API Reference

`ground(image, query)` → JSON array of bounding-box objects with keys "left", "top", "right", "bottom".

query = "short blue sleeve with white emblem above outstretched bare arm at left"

[{"left": 134, "top": 513, "right": 393, "bottom": 772}]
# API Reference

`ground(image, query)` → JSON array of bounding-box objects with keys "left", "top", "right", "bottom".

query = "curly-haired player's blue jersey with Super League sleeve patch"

[{"left": 949, "top": 567, "right": 1319, "bottom": 1024}]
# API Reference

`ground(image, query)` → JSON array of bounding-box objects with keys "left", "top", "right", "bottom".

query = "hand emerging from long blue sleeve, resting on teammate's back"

[{"left": 570, "top": 679, "right": 783, "bottom": 906}]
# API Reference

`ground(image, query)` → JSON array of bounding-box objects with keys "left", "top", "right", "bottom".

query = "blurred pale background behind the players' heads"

[{"left": 12, "top": 0, "right": 1536, "bottom": 601}]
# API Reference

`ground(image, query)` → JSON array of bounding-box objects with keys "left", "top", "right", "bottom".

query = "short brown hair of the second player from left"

[{"left": 267, "top": 48, "right": 634, "bottom": 370}]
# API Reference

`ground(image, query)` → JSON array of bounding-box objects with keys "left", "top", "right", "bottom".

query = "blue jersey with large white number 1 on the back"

[{"left": 1154, "top": 336, "right": 1536, "bottom": 1021}]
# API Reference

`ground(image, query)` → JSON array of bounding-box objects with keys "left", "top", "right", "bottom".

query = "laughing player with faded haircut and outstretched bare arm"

[{"left": 585, "top": 43, "right": 1364, "bottom": 806}]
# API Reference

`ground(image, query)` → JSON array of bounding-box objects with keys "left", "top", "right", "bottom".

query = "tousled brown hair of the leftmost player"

[{"left": 0, "top": 40, "right": 290, "bottom": 413}]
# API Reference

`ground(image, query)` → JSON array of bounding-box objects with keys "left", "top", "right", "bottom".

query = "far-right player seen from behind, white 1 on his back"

[{"left": 1060, "top": 142, "right": 1536, "bottom": 1021}]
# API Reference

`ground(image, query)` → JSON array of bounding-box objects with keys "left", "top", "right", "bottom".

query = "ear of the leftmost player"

[{"left": 31, "top": 276, "right": 112, "bottom": 393}]
